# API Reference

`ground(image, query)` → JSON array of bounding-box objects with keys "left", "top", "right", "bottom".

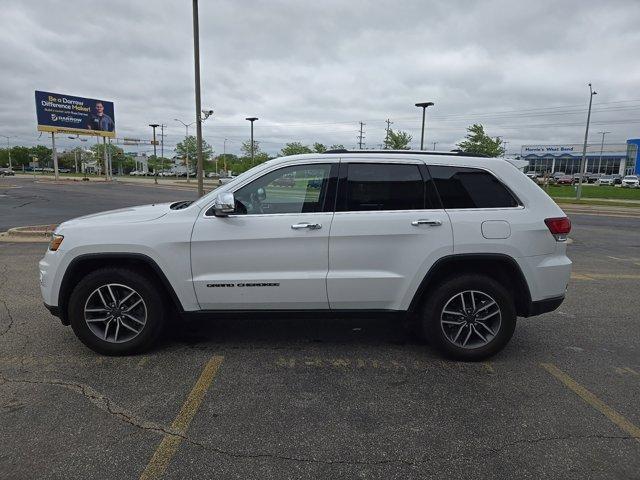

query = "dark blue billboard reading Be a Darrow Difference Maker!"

[{"left": 36, "top": 90, "right": 116, "bottom": 138}]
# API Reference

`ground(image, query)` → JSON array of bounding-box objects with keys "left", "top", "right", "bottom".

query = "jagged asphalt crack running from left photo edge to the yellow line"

[{"left": 0, "top": 374, "right": 180, "bottom": 439}]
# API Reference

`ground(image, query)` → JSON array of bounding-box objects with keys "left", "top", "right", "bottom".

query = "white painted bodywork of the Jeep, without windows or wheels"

[{"left": 40, "top": 154, "right": 571, "bottom": 312}]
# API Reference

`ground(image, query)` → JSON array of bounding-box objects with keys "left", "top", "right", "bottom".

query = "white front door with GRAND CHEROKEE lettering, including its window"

[{"left": 191, "top": 160, "right": 338, "bottom": 310}]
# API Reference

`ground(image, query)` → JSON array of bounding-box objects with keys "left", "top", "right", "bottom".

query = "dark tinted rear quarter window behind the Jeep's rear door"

[{"left": 429, "top": 166, "right": 519, "bottom": 208}]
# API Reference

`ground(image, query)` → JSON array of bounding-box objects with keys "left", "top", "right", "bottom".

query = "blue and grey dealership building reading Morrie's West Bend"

[{"left": 520, "top": 138, "right": 640, "bottom": 175}]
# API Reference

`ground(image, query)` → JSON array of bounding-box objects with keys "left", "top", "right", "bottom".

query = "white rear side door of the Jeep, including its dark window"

[{"left": 327, "top": 157, "right": 453, "bottom": 310}]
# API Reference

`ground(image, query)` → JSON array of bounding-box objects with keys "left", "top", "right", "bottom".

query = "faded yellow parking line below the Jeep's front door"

[{"left": 140, "top": 355, "right": 224, "bottom": 480}]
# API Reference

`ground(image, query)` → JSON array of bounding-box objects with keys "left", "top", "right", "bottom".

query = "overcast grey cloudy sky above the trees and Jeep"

[{"left": 0, "top": 0, "right": 640, "bottom": 153}]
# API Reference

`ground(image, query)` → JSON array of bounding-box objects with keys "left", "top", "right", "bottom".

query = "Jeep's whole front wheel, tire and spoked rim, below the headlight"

[{"left": 69, "top": 268, "right": 166, "bottom": 355}]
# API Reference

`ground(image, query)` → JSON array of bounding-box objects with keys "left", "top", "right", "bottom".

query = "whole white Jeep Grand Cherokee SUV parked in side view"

[{"left": 40, "top": 150, "right": 571, "bottom": 360}]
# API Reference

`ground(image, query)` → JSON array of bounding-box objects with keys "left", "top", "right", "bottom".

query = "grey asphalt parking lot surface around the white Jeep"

[{"left": 0, "top": 179, "right": 640, "bottom": 479}]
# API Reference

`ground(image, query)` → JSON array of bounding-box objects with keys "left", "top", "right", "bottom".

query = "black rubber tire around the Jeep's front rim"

[{"left": 68, "top": 267, "right": 166, "bottom": 356}]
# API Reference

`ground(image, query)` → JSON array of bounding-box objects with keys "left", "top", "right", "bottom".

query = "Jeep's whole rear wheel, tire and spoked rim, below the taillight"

[{"left": 423, "top": 274, "right": 516, "bottom": 361}]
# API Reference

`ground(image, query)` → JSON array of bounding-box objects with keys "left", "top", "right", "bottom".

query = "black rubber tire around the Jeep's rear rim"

[{"left": 422, "top": 274, "right": 516, "bottom": 361}]
